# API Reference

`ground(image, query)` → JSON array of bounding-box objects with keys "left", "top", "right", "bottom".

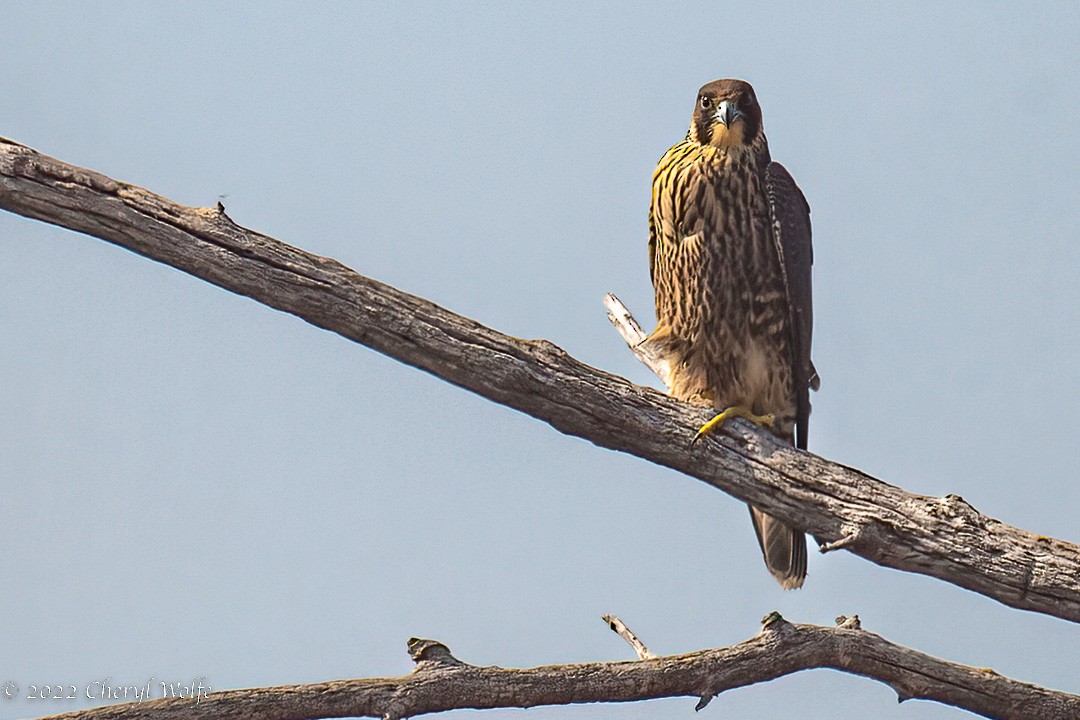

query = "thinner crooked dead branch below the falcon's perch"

[{"left": 33, "top": 612, "right": 1080, "bottom": 720}]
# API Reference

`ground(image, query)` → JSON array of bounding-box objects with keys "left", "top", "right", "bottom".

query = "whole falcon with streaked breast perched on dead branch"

[{"left": 649, "top": 80, "right": 819, "bottom": 588}]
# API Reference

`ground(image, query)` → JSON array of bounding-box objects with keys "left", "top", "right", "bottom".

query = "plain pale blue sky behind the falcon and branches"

[{"left": 0, "top": 2, "right": 1080, "bottom": 720}]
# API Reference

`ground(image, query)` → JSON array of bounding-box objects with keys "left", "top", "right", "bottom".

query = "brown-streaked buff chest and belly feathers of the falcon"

[{"left": 650, "top": 140, "right": 793, "bottom": 423}]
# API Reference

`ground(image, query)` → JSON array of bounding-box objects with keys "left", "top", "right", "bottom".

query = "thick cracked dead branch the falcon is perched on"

[{"left": 0, "top": 138, "right": 1080, "bottom": 622}]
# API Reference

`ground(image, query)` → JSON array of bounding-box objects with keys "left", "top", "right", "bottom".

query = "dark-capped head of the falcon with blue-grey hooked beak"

[{"left": 687, "top": 80, "right": 762, "bottom": 150}]
